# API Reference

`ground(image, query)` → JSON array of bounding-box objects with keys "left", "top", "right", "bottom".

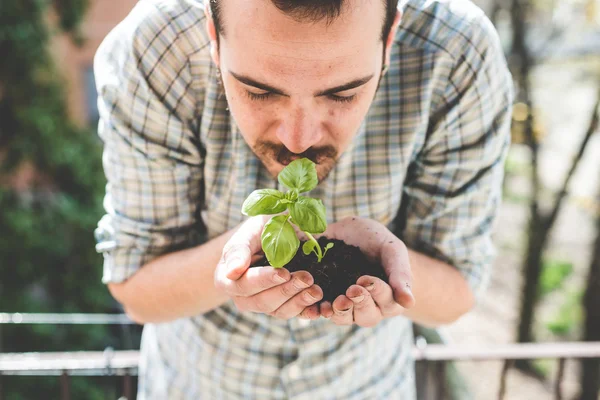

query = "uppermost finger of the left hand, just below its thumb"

[{"left": 215, "top": 267, "right": 291, "bottom": 297}]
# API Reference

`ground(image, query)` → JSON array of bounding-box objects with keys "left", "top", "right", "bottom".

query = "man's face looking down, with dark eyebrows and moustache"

[{"left": 209, "top": 0, "right": 392, "bottom": 181}]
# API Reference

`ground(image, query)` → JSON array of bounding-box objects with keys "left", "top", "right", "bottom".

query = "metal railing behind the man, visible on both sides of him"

[{"left": 0, "top": 314, "right": 600, "bottom": 400}]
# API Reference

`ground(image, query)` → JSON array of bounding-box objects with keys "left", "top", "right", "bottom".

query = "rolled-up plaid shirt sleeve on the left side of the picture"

[{"left": 94, "top": 2, "right": 203, "bottom": 283}]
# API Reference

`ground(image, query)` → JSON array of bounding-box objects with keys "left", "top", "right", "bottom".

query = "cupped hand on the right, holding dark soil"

[{"left": 301, "top": 217, "right": 415, "bottom": 327}]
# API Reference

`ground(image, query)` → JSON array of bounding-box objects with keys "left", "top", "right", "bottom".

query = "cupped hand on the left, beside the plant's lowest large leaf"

[{"left": 214, "top": 216, "right": 323, "bottom": 319}]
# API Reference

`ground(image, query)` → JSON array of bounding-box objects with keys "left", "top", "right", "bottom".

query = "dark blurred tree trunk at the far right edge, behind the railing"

[{"left": 580, "top": 188, "right": 600, "bottom": 400}]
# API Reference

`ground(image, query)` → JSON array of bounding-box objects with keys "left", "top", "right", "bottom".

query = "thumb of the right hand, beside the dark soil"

[{"left": 381, "top": 238, "right": 415, "bottom": 308}]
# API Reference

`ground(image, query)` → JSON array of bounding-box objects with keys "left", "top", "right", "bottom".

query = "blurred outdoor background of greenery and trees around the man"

[{"left": 0, "top": 0, "right": 600, "bottom": 400}]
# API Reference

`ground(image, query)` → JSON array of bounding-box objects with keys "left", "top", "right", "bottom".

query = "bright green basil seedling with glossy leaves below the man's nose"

[{"left": 242, "top": 158, "right": 333, "bottom": 268}]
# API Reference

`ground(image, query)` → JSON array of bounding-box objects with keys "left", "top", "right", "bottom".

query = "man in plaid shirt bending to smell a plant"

[{"left": 95, "top": 0, "right": 512, "bottom": 400}]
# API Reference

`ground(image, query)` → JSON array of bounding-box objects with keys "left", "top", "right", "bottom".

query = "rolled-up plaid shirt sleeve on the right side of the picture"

[{"left": 402, "top": 17, "right": 513, "bottom": 299}]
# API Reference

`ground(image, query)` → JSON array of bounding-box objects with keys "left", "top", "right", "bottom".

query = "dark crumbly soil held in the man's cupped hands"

[{"left": 256, "top": 237, "right": 387, "bottom": 303}]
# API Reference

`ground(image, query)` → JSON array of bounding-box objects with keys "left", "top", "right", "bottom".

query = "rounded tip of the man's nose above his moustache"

[{"left": 277, "top": 107, "right": 323, "bottom": 154}]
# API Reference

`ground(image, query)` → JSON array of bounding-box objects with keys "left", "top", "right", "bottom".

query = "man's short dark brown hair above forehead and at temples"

[{"left": 209, "top": 0, "right": 398, "bottom": 43}]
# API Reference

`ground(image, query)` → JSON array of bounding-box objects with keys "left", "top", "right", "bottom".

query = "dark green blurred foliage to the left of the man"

[{"left": 0, "top": 0, "right": 138, "bottom": 400}]
